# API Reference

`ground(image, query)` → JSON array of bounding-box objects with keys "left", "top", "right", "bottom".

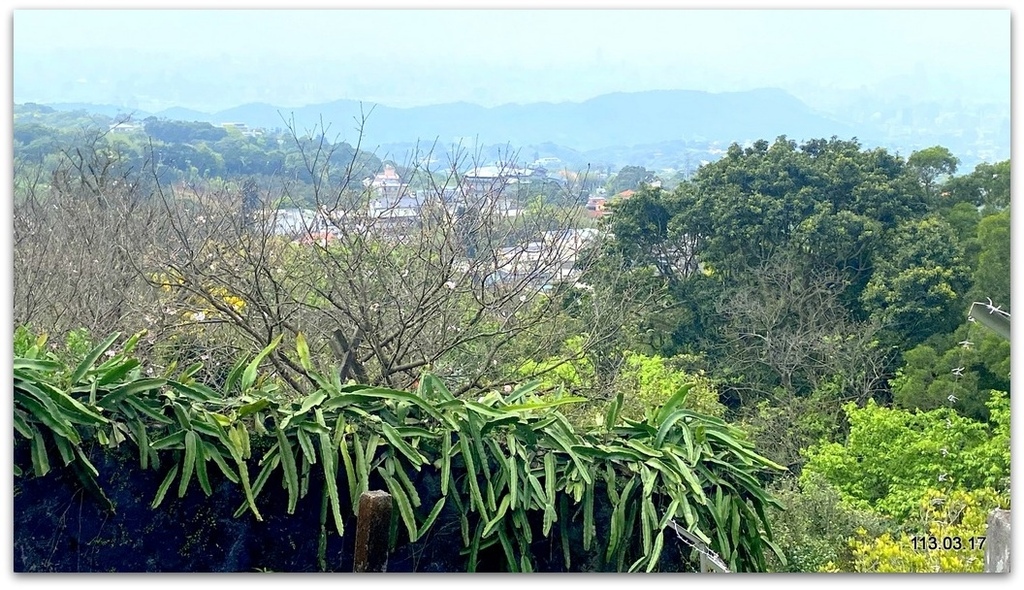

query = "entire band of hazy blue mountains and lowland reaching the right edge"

[{"left": 32, "top": 88, "right": 1010, "bottom": 173}]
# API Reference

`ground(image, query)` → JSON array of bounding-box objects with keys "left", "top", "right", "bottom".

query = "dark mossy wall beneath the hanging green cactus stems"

[{"left": 13, "top": 445, "right": 691, "bottom": 573}]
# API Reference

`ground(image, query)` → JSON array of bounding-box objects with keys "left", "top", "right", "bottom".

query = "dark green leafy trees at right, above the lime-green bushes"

[{"left": 591, "top": 137, "right": 1009, "bottom": 413}]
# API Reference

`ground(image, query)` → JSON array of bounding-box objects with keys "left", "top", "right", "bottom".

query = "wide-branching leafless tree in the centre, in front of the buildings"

[{"left": 142, "top": 115, "right": 641, "bottom": 399}]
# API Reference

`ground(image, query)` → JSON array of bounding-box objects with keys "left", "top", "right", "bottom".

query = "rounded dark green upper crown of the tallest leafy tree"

[{"left": 680, "top": 136, "right": 927, "bottom": 276}]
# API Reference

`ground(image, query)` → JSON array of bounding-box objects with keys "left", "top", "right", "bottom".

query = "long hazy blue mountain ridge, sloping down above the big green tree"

[{"left": 49, "top": 89, "right": 854, "bottom": 151}]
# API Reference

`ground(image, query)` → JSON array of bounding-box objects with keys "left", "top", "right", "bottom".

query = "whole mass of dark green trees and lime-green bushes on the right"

[{"left": 591, "top": 137, "right": 1010, "bottom": 571}]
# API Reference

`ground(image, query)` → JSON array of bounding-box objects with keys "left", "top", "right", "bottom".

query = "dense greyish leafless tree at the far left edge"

[{"left": 13, "top": 125, "right": 161, "bottom": 344}]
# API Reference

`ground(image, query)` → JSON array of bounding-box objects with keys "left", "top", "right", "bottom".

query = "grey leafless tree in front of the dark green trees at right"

[{"left": 718, "top": 255, "right": 887, "bottom": 470}]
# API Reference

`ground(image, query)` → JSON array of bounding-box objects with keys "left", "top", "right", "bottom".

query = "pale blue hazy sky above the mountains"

[{"left": 13, "top": 9, "right": 1011, "bottom": 110}]
